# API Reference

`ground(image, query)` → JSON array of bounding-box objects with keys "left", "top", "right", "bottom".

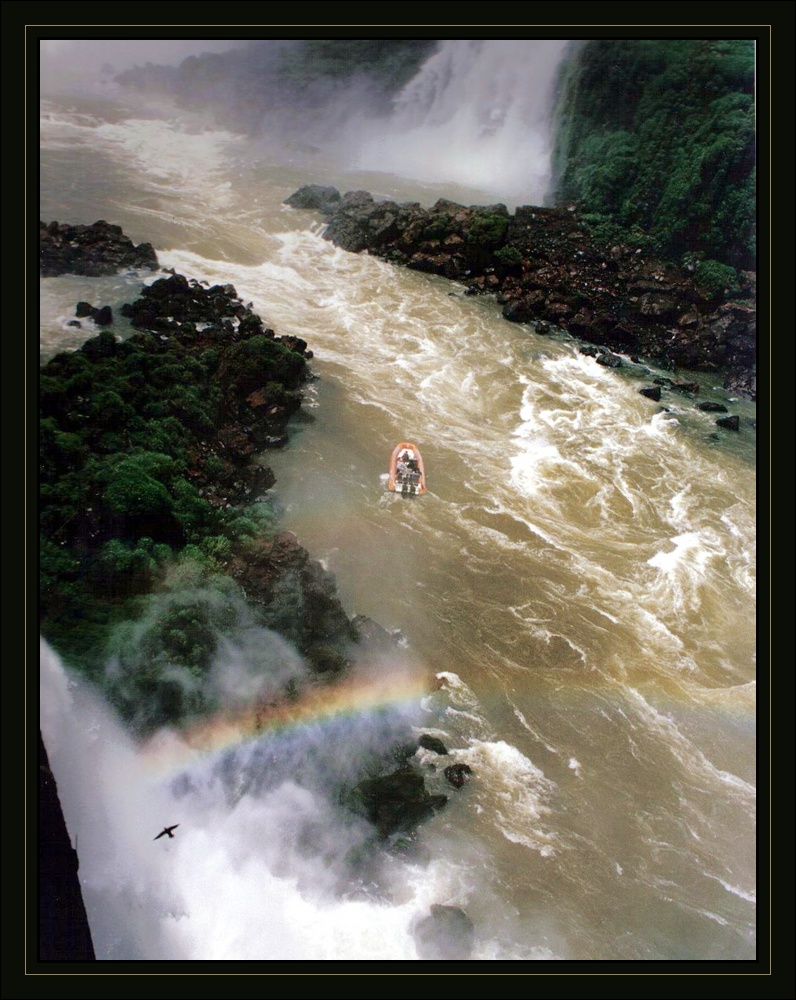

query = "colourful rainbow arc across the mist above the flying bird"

[{"left": 142, "top": 672, "right": 429, "bottom": 776}]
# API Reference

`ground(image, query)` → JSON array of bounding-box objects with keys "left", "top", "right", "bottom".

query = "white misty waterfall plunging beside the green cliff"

[{"left": 358, "top": 39, "right": 569, "bottom": 205}]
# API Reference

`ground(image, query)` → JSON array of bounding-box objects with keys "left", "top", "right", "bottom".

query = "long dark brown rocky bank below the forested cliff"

[{"left": 288, "top": 189, "right": 756, "bottom": 399}]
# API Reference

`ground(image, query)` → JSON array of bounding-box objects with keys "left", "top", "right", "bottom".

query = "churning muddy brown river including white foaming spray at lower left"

[{"left": 40, "top": 80, "right": 756, "bottom": 961}]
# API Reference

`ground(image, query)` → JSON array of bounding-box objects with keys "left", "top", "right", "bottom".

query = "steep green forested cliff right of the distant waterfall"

[{"left": 555, "top": 39, "right": 755, "bottom": 268}]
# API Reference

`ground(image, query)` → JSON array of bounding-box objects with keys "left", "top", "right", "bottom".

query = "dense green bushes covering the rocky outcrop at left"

[{"left": 39, "top": 276, "right": 306, "bottom": 688}]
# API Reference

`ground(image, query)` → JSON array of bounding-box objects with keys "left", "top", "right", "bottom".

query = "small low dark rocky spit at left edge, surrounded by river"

[{"left": 39, "top": 220, "right": 158, "bottom": 277}]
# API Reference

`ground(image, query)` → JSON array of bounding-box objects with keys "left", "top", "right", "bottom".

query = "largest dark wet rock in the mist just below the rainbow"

[{"left": 346, "top": 766, "right": 448, "bottom": 837}]
